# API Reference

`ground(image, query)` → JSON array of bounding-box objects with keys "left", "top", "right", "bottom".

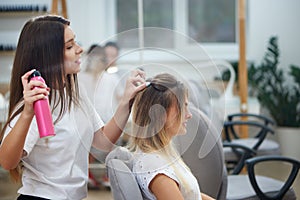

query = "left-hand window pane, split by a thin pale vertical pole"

[{"left": 116, "top": 0, "right": 174, "bottom": 48}]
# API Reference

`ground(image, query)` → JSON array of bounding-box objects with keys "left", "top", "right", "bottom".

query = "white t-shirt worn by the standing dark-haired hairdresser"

[{"left": 5, "top": 91, "right": 103, "bottom": 200}]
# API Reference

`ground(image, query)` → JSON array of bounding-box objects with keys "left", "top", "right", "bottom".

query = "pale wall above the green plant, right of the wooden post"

[{"left": 247, "top": 0, "right": 300, "bottom": 67}]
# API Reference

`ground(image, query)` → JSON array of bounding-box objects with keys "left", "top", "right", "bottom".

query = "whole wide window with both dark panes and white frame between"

[{"left": 111, "top": 0, "right": 238, "bottom": 59}]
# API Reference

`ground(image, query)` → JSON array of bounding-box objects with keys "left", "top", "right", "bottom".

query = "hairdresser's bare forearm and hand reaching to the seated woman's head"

[{"left": 93, "top": 70, "right": 146, "bottom": 151}]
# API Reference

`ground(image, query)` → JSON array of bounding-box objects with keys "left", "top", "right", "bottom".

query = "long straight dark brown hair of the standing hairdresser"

[{"left": 1, "top": 15, "right": 79, "bottom": 181}]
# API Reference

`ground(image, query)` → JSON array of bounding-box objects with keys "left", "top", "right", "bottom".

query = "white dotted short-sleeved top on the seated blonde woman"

[{"left": 132, "top": 152, "right": 201, "bottom": 200}]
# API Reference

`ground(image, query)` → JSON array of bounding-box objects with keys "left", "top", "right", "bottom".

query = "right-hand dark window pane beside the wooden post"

[{"left": 188, "top": 0, "right": 236, "bottom": 43}]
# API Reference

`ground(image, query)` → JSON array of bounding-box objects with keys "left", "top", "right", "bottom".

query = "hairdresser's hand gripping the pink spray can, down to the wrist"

[{"left": 21, "top": 69, "right": 50, "bottom": 116}]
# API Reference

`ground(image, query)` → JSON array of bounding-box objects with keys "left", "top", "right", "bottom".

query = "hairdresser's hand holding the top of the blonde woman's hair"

[{"left": 122, "top": 69, "right": 146, "bottom": 103}]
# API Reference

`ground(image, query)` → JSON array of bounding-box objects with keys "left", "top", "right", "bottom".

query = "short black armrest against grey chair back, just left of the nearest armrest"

[{"left": 223, "top": 142, "right": 256, "bottom": 174}]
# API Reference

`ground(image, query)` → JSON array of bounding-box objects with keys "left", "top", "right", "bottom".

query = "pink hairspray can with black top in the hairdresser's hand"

[{"left": 29, "top": 71, "right": 55, "bottom": 138}]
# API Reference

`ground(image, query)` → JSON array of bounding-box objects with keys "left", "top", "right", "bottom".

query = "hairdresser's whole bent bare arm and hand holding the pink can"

[{"left": 0, "top": 70, "right": 49, "bottom": 170}]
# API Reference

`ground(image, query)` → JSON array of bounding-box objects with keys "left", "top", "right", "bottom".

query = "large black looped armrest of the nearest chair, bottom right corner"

[{"left": 245, "top": 155, "right": 300, "bottom": 200}]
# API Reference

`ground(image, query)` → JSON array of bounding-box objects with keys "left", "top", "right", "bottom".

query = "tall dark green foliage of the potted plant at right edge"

[{"left": 248, "top": 37, "right": 300, "bottom": 127}]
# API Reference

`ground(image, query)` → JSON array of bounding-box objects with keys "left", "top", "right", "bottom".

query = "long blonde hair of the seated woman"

[{"left": 128, "top": 73, "right": 189, "bottom": 190}]
